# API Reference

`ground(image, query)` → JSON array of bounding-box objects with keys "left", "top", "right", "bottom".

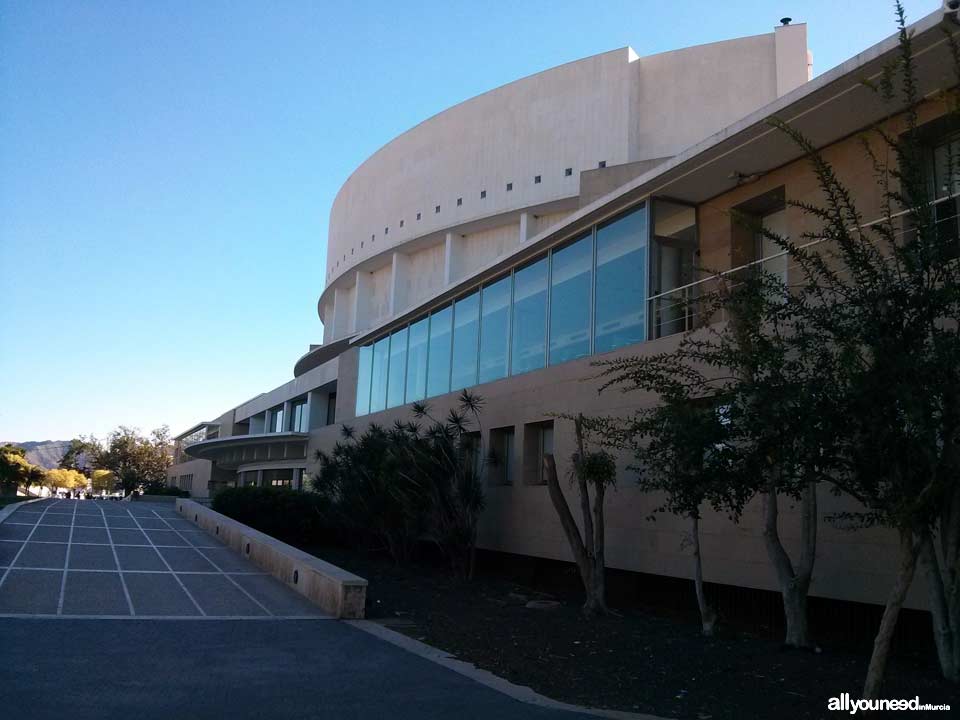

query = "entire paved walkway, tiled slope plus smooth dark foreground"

[{"left": 0, "top": 500, "right": 604, "bottom": 720}]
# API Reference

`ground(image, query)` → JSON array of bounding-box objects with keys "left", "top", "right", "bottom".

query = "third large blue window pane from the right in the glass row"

[{"left": 510, "top": 257, "right": 547, "bottom": 375}]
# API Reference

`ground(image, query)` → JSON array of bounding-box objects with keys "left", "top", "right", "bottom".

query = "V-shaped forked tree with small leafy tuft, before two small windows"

[{"left": 543, "top": 415, "right": 617, "bottom": 618}]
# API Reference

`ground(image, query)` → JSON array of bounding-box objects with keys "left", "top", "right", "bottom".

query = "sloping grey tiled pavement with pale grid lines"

[{"left": 0, "top": 500, "right": 327, "bottom": 619}]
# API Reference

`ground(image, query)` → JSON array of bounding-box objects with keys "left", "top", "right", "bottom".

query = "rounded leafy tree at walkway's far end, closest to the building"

[{"left": 88, "top": 426, "right": 172, "bottom": 494}]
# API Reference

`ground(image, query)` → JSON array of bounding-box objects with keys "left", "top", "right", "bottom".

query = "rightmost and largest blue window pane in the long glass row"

[{"left": 593, "top": 208, "right": 647, "bottom": 353}]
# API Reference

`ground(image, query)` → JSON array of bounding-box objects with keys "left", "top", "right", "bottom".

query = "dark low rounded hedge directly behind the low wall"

[{"left": 212, "top": 486, "right": 331, "bottom": 543}]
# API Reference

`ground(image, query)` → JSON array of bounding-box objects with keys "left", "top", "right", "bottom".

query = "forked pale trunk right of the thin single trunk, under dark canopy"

[{"left": 763, "top": 482, "right": 817, "bottom": 648}]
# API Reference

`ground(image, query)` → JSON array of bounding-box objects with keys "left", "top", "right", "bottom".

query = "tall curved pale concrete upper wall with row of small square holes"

[{"left": 318, "top": 25, "right": 808, "bottom": 342}]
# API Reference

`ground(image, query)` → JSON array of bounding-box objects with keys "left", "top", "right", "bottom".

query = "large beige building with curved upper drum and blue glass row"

[{"left": 170, "top": 8, "right": 955, "bottom": 608}]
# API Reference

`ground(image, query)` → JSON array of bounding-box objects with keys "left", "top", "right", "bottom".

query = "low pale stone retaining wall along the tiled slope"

[{"left": 176, "top": 498, "right": 367, "bottom": 619}]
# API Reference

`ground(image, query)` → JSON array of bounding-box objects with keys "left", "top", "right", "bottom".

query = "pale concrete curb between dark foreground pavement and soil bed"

[{"left": 343, "top": 620, "right": 667, "bottom": 720}]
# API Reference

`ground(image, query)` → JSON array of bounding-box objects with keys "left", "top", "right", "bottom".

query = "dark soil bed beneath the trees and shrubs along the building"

[{"left": 306, "top": 547, "right": 960, "bottom": 720}]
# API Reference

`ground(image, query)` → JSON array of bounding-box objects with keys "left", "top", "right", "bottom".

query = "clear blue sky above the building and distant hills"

[{"left": 0, "top": 0, "right": 940, "bottom": 441}]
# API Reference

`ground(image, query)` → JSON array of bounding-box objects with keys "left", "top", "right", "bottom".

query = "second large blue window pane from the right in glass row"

[{"left": 550, "top": 235, "right": 593, "bottom": 365}]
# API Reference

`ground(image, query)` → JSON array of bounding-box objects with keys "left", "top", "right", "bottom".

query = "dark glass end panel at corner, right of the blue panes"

[{"left": 650, "top": 200, "right": 697, "bottom": 338}]
